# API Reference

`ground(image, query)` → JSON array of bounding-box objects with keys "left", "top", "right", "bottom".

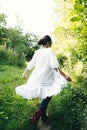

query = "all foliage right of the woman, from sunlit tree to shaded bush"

[{"left": 49, "top": 0, "right": 87, "bottom": 130}]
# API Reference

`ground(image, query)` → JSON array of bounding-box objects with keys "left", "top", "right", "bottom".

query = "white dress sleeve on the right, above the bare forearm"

[{"left": 50, "top": 52, "right": 59, "bottom": 68}]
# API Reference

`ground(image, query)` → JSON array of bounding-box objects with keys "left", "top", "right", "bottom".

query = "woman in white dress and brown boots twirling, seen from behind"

[{"left": 16, "top": 35, "right": 71, "bottom": 127}]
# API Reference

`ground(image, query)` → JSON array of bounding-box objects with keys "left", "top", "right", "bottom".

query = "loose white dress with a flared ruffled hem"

[{"left": 16, "top": 48, "right": 67, "bottom": 99}]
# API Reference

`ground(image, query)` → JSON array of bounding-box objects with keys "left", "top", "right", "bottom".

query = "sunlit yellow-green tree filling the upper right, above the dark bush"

[{"left": 53, "top": 0, "right": 87, "bottom": 71}]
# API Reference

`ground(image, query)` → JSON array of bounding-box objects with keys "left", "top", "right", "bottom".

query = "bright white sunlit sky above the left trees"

[{"left": 0, "top": 0, "right": 54, "bottom": 35}]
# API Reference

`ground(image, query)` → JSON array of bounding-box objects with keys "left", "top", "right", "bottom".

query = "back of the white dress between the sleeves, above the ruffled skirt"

[{"left": 29, "top": 48, "right": 54, "bottom": 86}]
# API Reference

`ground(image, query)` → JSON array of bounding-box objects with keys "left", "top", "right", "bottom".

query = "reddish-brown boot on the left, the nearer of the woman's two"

[{"left": 32, "top": 107, "right": 42, "bottom": 128}]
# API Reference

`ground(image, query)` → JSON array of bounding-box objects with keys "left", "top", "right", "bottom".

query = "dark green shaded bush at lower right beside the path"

[{"left": 49, "top": 84, "right": 87, "bottom": 130}]
